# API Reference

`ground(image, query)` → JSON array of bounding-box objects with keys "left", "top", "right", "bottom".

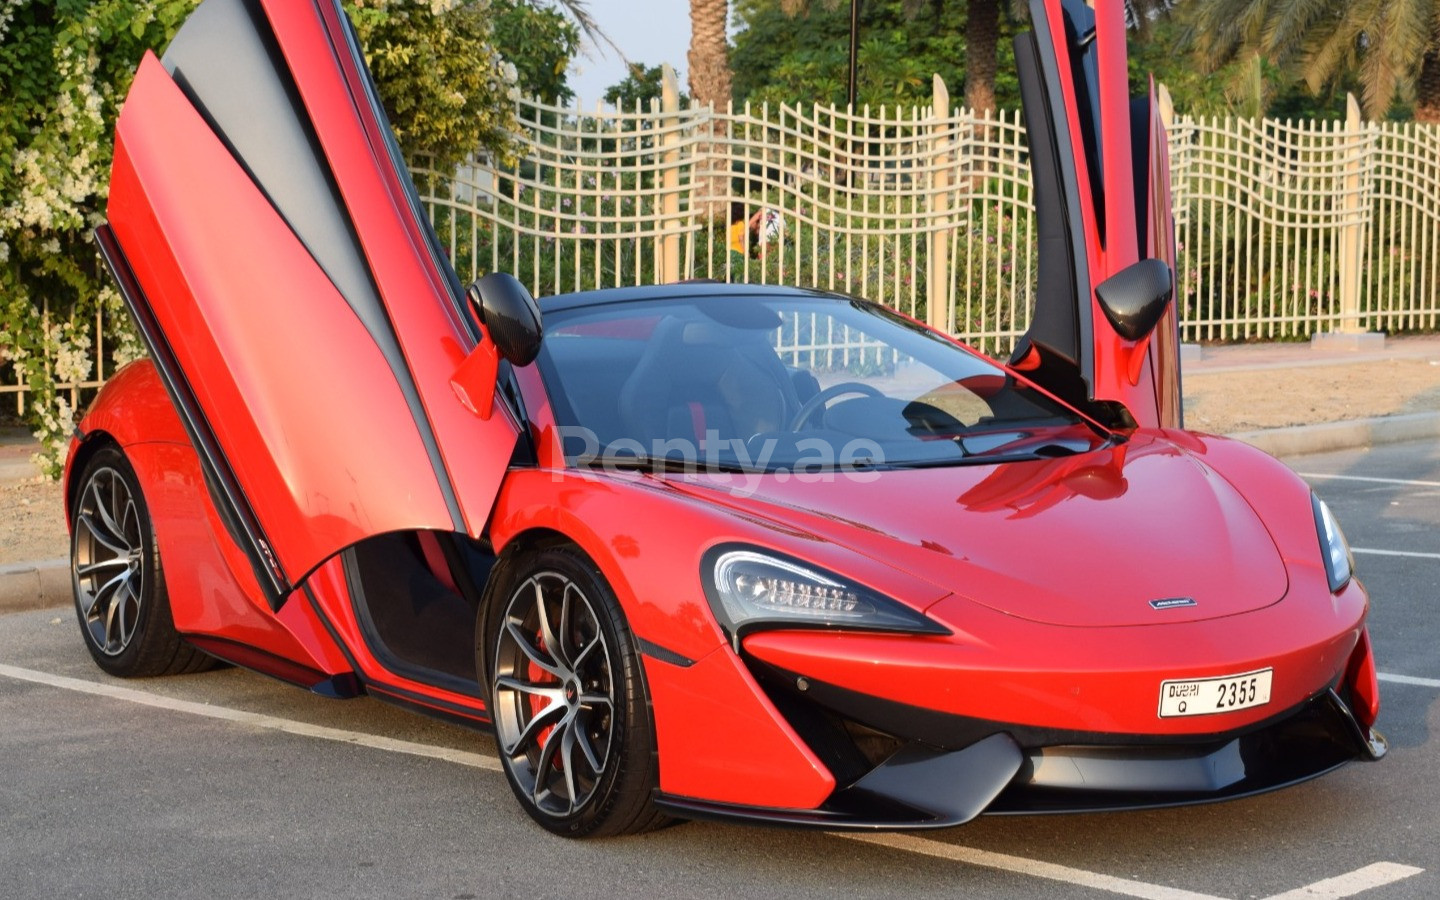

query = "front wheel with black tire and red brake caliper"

[{"left": 477, "top": 547, "right": 668, "bottom": 838}]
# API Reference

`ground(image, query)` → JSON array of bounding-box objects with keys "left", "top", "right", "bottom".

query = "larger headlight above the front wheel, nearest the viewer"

[{"left": 700, "top": 544, "right": 950, "bottom": 649}]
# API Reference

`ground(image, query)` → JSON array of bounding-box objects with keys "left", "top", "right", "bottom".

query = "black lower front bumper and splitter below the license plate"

[{"left": 658, "top": 610, "right": 1385, "bottom": 829}]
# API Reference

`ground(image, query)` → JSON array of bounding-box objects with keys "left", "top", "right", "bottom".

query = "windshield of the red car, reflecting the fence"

[{"left": 539, "top": 294, "right": 1107, "bottom": 472}]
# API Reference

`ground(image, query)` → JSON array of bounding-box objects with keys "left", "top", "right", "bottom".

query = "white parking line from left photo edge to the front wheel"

[{"left": 0, "top": 662, "right": 500, "bottom": 772}]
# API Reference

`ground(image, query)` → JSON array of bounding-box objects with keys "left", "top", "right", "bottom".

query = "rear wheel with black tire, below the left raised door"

[{"left": 71, "top": 446, "right": 215, "bottom": 678}]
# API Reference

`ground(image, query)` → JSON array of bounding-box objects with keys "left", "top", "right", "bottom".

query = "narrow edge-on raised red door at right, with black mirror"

[{"left": 1011, "top": 0, "right": 1182, "bottom": 428}]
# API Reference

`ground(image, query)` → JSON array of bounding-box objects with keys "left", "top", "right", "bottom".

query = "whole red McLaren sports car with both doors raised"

[{"left": 66, "top": 0, "right": 1385, "bottom": 837}]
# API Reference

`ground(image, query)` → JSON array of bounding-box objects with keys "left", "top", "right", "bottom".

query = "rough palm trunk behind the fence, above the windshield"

[{"left": 687, "top": 0, "right": 730, "bottom": 219}]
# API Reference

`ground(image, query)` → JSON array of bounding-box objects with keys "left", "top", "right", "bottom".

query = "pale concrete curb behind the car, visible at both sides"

[{"left": 0, "top": 412, "right": 1440, "bottom": 615}]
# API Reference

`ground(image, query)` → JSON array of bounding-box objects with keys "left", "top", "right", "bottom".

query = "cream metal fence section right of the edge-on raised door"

[{"left": 1171, "top": 98, "right": 1440, "bottom": 340}]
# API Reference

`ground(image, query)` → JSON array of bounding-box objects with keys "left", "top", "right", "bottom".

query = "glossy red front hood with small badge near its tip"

[{"left": 672, "top": 433, "right": 1287, "bottom": 626}]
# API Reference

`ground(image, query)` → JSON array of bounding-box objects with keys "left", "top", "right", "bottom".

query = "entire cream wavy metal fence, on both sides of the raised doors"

[{"left": 0, "top": 73, "right": 1440, "bottom": 410}]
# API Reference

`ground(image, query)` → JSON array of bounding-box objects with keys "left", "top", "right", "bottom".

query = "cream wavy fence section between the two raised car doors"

[{"left": 416, "top": 72, "right": 1035, "bottom": 351}]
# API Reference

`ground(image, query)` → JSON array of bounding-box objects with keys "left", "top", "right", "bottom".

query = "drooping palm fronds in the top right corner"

[{"left": 1191, "top": 0, "right": 1440, "bottom": 122}]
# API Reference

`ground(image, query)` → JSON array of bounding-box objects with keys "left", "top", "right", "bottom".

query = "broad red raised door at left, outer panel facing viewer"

[{"left": 98, "top": 0, "right": 520, "bottom": 609}]
